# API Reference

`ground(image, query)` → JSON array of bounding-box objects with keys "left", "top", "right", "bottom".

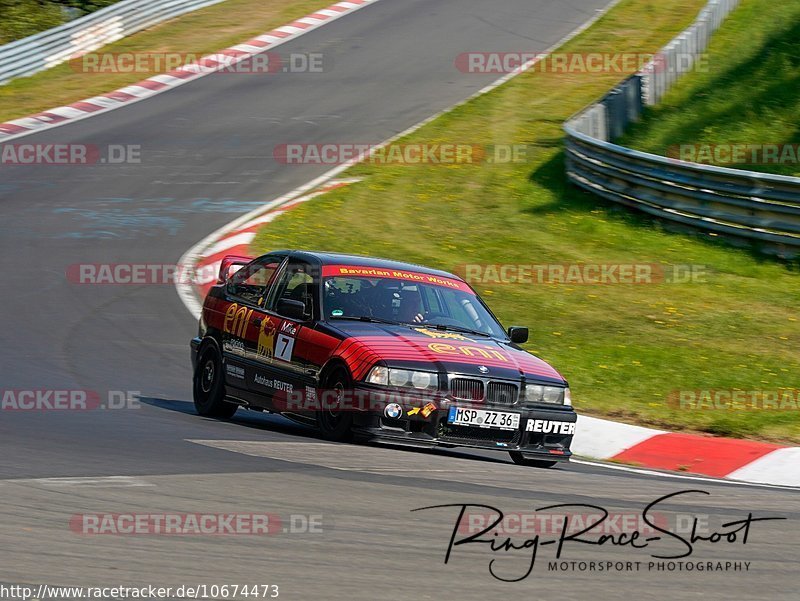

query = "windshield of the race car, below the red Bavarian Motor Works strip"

[{"left": 323, "top": 276, "right": 506, "bottom": 338}]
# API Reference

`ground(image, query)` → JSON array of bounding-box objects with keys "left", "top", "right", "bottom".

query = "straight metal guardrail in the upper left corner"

[{"left": 0, "top": 0, "right": 223, "bottom": 84}]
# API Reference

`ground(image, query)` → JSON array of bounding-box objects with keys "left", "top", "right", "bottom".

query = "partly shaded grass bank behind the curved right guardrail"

[{"left": 620, "top": 0, "right": 800, "bottom": 176}]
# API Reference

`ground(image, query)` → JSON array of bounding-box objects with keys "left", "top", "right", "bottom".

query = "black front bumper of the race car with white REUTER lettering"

[{"left": 354, "top": 386, "right": 577, "bottom": 461}]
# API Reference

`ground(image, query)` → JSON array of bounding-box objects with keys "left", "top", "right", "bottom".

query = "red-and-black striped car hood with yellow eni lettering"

[{"left": 324, "top": 321, "right": 564, "bottom": 383}]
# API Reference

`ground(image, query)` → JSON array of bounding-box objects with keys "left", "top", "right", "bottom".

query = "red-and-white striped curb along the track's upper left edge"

[{"left": 0, "top": 0, "right": 379, "bottom": 142}]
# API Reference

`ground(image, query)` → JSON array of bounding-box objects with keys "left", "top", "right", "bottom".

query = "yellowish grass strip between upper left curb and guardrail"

[{"left": 0, "top": 0, "right": 332, "bottom": 122}]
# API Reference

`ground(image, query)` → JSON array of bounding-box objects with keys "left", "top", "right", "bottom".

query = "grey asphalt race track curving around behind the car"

[{"left": 0, "top": 0, "right": 800, "bottom": 600}]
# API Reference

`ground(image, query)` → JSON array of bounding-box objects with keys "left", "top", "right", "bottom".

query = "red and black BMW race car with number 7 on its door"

[{"left": 191, "top": 250, "right": 577, "bottom": 467}]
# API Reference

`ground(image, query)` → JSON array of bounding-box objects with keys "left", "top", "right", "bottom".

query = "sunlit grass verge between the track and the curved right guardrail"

[{"left": 254, "top": 0, "right": 800, "bottom": 442}]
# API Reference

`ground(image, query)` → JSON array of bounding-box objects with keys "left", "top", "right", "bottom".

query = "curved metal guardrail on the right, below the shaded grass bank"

[{"left": 564, "top": 0, "right": 800, "bottom": 258}]
